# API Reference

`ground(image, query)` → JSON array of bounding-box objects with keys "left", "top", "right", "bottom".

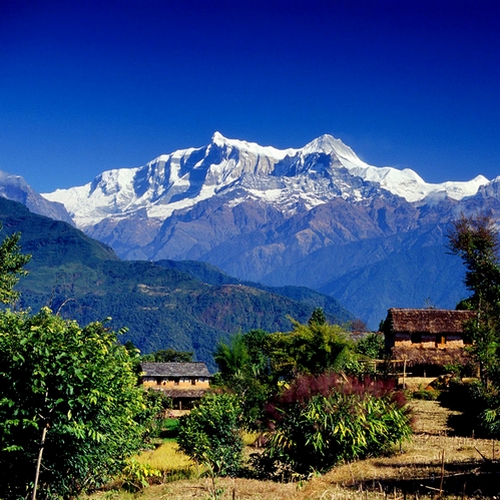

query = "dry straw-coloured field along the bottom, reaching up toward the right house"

[{"left": 92, "top": 387, "right": 500, "bottom": 500}]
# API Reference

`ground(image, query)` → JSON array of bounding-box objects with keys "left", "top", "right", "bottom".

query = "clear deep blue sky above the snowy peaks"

[{"left": 0, "top": 0, "right": 500, "bottom": 192}]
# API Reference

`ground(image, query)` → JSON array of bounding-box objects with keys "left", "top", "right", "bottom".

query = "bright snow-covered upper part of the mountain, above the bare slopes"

[{"left": 43, "top": 132, "right": 489, "bottom": 230}]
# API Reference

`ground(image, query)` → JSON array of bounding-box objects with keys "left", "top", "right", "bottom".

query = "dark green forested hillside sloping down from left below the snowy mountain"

[{"left": 0, "top": 198, "right": 353, "bottom": 369}]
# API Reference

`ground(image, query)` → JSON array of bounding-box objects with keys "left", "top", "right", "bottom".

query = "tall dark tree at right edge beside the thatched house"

[{"left": 448, "top": 214, "right": 500, "bottom": 385}]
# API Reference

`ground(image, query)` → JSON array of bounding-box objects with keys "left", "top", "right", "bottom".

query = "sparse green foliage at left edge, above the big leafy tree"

[{"left": 0, "top": 223, "right": 31, "bottom": 304}]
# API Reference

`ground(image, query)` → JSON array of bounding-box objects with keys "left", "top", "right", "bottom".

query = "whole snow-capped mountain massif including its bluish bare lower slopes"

[{"left": 6, "top": 132, "right": 500, "bottom": 328}]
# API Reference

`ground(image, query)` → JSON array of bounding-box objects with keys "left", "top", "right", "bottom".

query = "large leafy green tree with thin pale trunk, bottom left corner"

[{"left": 0, "top": 308, "right": 146, "bottom": 499}]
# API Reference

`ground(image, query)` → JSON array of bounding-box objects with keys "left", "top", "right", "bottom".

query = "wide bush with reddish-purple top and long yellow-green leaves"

[{"left": 260, "top": 374, "right": 411, "bottom": 476}]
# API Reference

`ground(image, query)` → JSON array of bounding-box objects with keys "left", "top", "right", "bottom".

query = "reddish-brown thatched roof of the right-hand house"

[{"left": 384, "top": 308, "right": 476, "bottom": 335}]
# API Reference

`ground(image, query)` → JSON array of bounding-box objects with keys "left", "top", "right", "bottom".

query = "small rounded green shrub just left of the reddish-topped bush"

[{"left": 177, "top": 394, "right": 243, "bottom": 476}]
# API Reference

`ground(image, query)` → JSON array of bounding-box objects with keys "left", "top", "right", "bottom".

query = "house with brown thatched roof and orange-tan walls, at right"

[{"left": 383, "top": 308, "right": 476, "bottom": 374}]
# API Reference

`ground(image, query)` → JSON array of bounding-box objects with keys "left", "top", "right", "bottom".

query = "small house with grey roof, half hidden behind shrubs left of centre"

[{"left": 141, "top": 362, "right": 211, "bottom": 410}]
